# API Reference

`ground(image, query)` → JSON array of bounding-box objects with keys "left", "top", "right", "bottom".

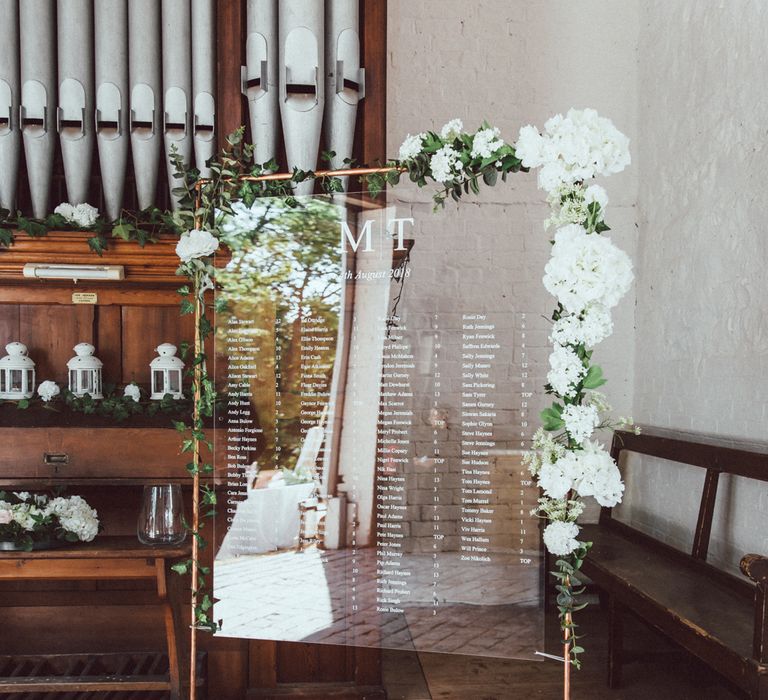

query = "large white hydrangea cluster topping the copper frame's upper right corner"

[{"left": 515, "top": 109, "right": 631, "bottom": 192}]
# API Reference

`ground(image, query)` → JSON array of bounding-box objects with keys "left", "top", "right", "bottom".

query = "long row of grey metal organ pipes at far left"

[{"left": 0, "top": 0, "right": 216, "bottom": 219}]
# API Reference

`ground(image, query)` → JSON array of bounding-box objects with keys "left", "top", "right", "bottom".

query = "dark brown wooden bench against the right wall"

[{"left": 582, "top": 431, "right": 768, "bottom": 700}]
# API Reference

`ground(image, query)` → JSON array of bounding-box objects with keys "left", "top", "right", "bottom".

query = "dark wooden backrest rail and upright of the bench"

[{"left": 600, "top": 429, "right": 768, "bottom": 561}]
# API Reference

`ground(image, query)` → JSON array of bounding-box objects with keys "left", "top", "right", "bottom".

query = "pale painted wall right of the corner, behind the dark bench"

[{"left": 625, "top": 0, "right": 768, "bottom": 568}]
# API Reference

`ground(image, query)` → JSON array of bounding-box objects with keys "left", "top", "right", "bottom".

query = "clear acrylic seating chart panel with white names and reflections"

[{"left": 214, "top": 195, "right": 544, "bottom": 658}]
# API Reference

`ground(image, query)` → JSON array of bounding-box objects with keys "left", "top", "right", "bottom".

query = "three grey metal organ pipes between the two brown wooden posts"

[{"left": 243, "top": 0, "right": 365, "bottom": 194}]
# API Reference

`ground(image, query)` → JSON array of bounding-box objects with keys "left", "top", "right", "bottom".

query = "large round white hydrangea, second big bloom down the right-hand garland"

[{"left": 543, "top": 224, "right": 633, "bottom": 314}]
